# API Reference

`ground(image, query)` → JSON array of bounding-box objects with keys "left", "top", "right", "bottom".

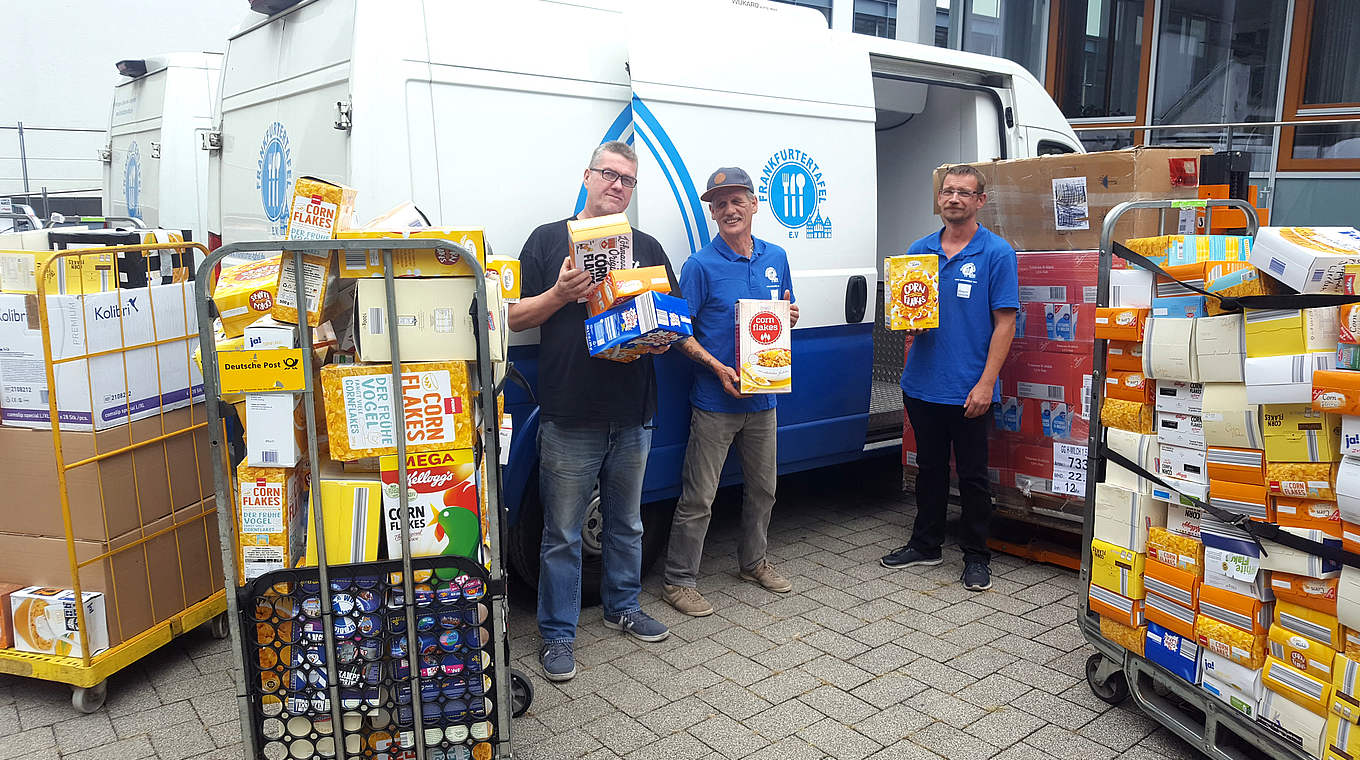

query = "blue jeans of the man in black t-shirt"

[{"left": 539, "top": 420, "right": 651, "bottom": 643}]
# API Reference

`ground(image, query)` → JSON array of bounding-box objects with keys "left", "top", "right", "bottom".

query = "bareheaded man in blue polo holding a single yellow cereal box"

[{"left": 880, "top": 166, "right": 1020, "bottom": 591}]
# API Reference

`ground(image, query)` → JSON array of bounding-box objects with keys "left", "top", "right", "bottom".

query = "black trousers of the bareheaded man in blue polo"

[{"left": 902, "top": 394, "right": 993, "bottom": 564}]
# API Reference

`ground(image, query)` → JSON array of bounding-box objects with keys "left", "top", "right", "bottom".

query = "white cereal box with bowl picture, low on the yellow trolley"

[{"left": 10, "top": 586, "right": 109, "bottom": 657}]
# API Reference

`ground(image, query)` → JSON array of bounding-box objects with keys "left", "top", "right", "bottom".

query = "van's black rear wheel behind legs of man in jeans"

[{"left": 507, "top": 468, "right": 675, "bottom": 608}]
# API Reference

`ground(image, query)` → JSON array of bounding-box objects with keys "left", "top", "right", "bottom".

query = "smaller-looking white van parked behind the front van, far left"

[{"left": 103, "top": 53, "right": 222, "bottom": 242}]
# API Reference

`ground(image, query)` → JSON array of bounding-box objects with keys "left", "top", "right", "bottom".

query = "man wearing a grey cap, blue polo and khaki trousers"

[{"left": 664, "top": 167, "right": 798, "bottom": 617}]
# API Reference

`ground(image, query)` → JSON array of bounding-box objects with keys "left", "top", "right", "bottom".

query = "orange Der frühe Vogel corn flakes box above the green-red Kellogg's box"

[{"left": 321, "top": 362, "right": 473, "bottom": 461}]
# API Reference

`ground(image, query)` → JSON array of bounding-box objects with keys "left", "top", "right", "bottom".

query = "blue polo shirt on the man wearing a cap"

[{"left": 680, "top": 235, "right": 793, "bottom": 413}]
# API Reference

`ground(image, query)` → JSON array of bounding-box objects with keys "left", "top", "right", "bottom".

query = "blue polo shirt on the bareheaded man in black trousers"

[{"left": 902, "top": 224, "right": 1020, "bottom": 407}]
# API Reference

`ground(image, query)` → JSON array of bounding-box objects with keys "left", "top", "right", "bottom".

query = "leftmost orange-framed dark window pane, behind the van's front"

[{"left": 1057, "top": 0, "right": 1145, "bottom": 120}]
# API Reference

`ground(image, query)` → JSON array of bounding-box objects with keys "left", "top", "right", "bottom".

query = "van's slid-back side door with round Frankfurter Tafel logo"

[{"left": 628, "top": 0, "right": 877, "bottom": 470}]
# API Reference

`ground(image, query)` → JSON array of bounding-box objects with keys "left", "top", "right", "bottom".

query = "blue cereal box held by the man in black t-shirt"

[{"left": 586, "top": 291, "right": 694, "bottom": 362}]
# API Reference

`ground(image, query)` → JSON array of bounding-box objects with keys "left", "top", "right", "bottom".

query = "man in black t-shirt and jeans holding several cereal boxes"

[{"left": 510, "top": 141, "right": 680, "bottom": 681}]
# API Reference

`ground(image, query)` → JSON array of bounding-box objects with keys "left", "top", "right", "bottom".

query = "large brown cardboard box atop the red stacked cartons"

[{"left": 934, "top": 148, "right": 1208, "bottom": 250}]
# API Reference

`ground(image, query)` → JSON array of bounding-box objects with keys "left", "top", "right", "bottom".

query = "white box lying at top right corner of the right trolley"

[{"left": 1250, "top": 227, "right": 1360, "bottom": 294}]
